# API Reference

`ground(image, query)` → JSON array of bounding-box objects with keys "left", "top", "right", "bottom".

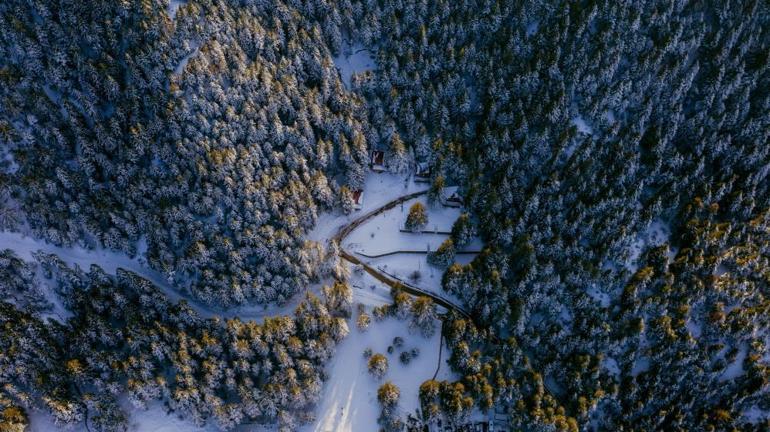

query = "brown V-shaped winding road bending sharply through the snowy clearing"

[{"left": 329, "top": 190, "right": 471, "bottom": 318}]
